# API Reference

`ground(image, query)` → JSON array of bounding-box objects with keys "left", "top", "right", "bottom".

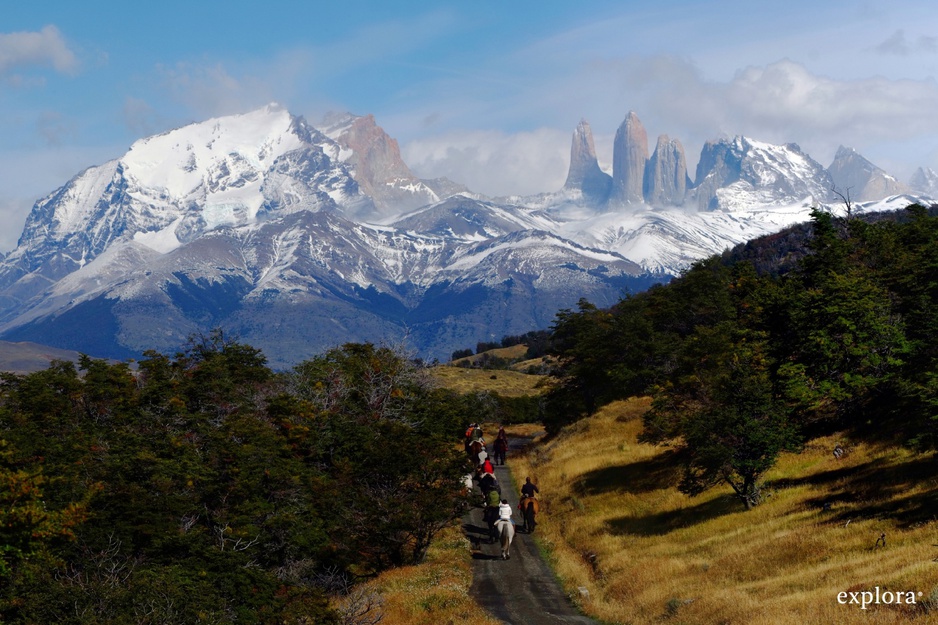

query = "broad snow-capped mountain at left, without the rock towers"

[{"left": 0, "top": 106, "right": 655, "bottom": 366}]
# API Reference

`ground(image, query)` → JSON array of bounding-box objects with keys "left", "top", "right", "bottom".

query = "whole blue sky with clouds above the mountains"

[{"left": 0, "top": 0, "right": 938, "bottom": 252}]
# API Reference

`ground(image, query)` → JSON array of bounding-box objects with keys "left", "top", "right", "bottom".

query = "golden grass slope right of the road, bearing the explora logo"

[{"left": 512, "top": 399, "right": 938, "bottom": 625}]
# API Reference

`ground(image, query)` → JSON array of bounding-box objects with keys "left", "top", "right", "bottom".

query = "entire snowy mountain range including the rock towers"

[{"left": 0, "top": 105, "right": 938, "bottom": 367}]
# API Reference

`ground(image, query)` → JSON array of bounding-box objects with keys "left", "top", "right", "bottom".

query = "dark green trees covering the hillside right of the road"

[{"left": 545, "top": 205, "right": 938, "bottom": 508}]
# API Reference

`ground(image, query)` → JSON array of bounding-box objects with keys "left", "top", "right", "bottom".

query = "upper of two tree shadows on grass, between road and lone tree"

[{"left": 576, "top": 450, "right": 682, "bottom": 495}]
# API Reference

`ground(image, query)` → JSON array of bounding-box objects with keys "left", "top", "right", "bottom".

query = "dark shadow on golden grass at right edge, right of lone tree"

[{"left": 768, "top": 456, "right": 938, "bottom": 528}]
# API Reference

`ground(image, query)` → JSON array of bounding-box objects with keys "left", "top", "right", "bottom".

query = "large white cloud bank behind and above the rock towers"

[{"left": 396, "top": 55, "right": 938, "bottom": 195}]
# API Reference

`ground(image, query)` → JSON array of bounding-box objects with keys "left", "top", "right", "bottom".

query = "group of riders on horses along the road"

[{"left": 466, "top": 428, "right": 538, "bottom": 560}]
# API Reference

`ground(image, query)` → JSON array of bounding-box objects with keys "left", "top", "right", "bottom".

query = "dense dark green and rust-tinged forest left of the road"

[{"left": 0, "top": 332, "right": 476, "bottom": 624}]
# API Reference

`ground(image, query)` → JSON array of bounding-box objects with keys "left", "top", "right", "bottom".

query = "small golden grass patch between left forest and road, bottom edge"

[{"left": 342, "top": 525, "right": 500, "bottom": 625}]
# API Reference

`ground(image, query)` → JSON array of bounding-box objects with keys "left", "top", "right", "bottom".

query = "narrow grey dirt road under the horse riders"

[{"left": 463, "top": 446, "right": 597, "bottom": 625}]
